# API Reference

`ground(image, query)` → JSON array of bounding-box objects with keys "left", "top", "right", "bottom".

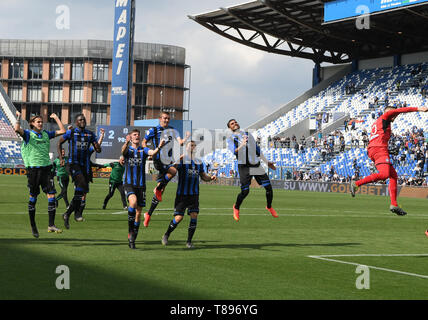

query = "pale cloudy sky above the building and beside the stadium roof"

[{"left": 0, "top": 0, "right": 313, "bottom": 129}]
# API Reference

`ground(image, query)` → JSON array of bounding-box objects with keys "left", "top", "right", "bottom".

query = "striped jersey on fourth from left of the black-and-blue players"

[{"left": 177, "top": 157, "right": 206, "bottom": 196}]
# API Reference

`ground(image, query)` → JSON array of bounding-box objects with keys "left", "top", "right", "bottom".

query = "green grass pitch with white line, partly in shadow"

[{"left": 0, "top": 175, "right": 428, "bottom": 300}]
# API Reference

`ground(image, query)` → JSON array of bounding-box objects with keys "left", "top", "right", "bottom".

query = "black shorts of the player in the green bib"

[{"left": 27, "top": 166, "right": 56, "bottom": 197}]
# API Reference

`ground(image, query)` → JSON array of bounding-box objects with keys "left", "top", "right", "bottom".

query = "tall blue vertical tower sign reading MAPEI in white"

[{"left": 110, "top": 0, "right": 134, "bottom": 125}]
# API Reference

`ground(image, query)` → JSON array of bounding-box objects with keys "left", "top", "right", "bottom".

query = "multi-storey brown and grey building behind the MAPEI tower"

[{"left": 0, "top": 39, "right": 190, "bottom": 125}]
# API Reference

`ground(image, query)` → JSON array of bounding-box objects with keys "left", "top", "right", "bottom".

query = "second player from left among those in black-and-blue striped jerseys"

[{"left": 122, "top": 129, "right": 165, "bottom": 249}]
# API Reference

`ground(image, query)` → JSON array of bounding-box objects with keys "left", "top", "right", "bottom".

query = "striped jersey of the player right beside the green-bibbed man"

[{"left": 62, "top": 128, "right": 97, "bottom": 168}]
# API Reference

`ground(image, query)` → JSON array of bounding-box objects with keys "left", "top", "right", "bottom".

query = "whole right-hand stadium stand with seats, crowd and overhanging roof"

[{"left": 195, "top": 0, "right": 428, "bottom": 185}]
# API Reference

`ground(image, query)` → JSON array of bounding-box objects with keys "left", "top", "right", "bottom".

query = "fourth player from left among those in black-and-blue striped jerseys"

[{"left": 162, "top": 141, "right": 217, "bottom": 249}]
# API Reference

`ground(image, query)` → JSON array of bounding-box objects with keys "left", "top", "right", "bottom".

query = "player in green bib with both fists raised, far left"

[{"left": 14, "top": 111, "right": 65, "bottom": 238}]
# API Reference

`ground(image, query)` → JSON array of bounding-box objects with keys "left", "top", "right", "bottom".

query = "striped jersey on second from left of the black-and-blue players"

[{"left": 123, "top": 147, "right": 150, "bottom": 188}]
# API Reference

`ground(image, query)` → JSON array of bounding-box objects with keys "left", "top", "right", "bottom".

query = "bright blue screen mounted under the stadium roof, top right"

[{"left": 324, "top": 0, "right": 428, "bottom": 22}]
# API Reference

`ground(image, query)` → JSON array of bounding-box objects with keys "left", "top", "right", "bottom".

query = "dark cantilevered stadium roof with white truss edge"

[{"left": 189, "top": 0, "right": 428, "bottom": 64}]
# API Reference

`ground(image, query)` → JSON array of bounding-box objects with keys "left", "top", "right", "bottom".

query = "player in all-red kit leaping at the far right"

[{"left": 350, "top": 106, "right": 428, "bottom": 216}]
